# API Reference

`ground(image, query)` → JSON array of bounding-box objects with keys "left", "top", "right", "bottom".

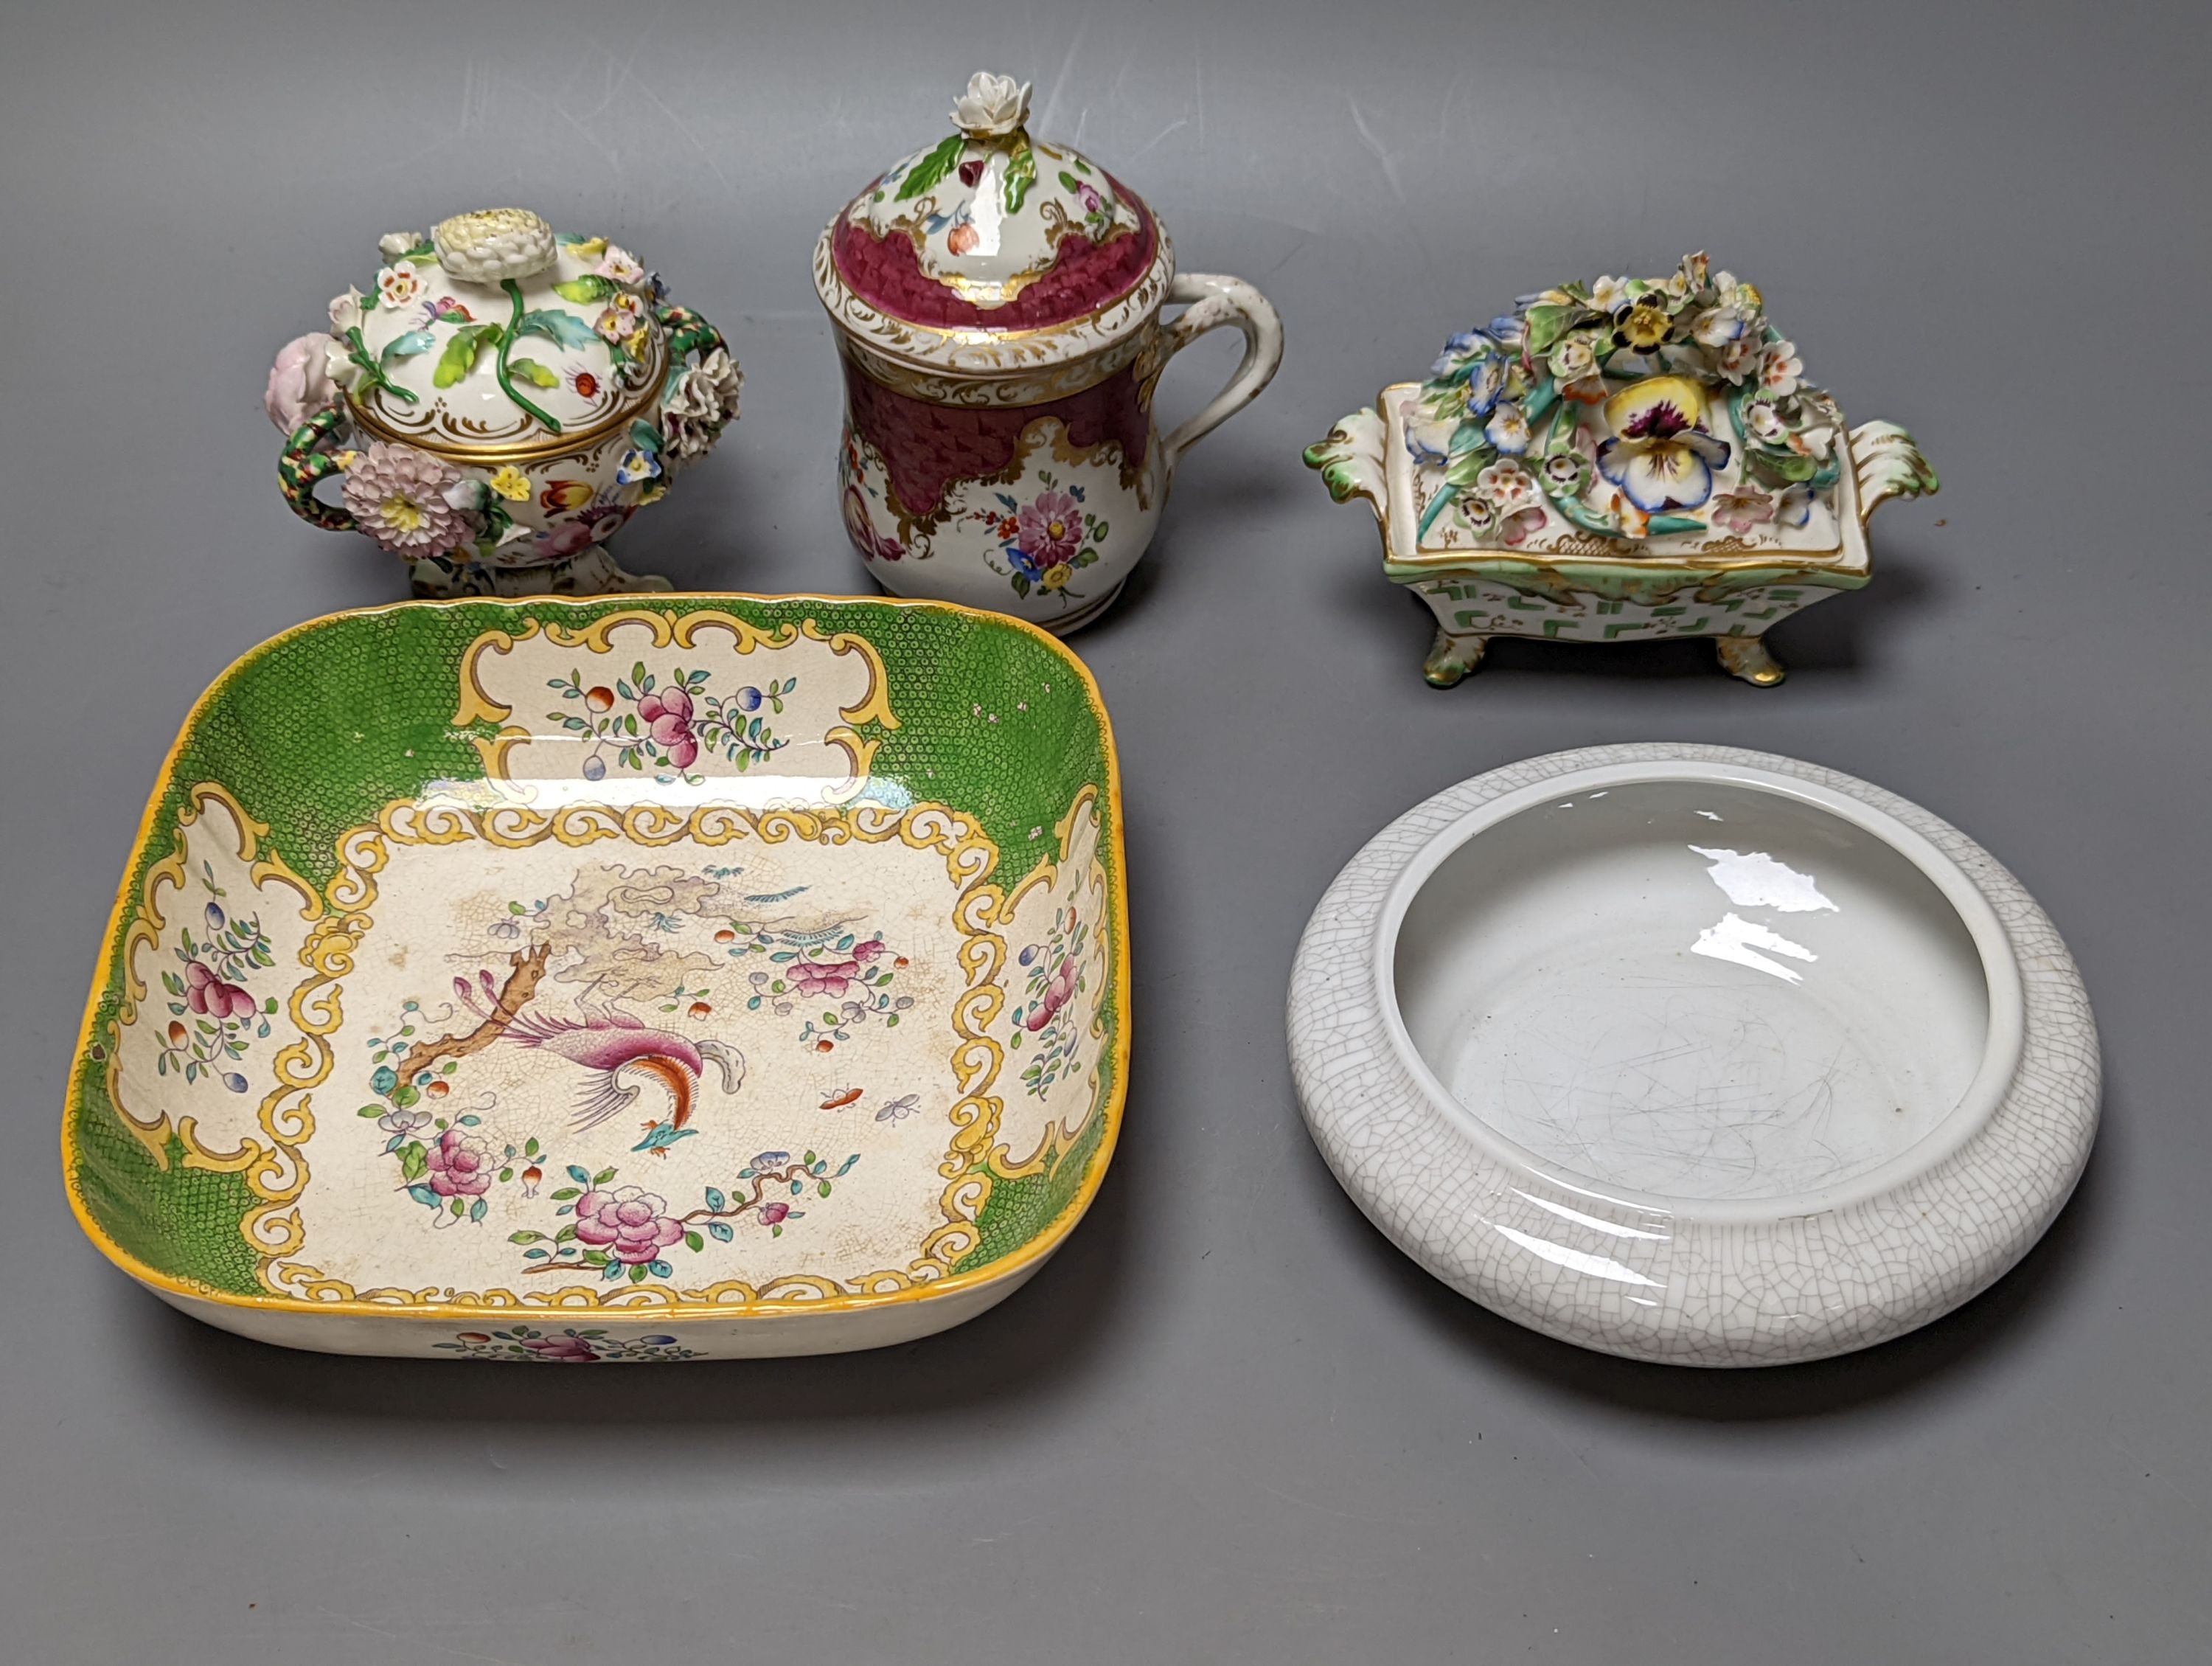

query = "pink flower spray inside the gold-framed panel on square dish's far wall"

[{"left": 546, "top": 659, "right": 799, "bottom": 781}]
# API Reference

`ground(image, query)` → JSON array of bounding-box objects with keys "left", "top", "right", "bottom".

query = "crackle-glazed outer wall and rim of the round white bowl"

[{"left": 1290, "top": 746, "right": 2099, "bottom": 1365}]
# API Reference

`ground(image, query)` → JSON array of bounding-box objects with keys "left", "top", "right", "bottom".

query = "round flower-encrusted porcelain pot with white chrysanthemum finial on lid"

[{"left": 268, "top": 208, "right": 741, "bottom": 595}]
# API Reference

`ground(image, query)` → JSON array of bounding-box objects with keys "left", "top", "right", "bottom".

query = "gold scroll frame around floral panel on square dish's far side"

[{"left": 453, "top": 608, "right": 898, "bottom": 801}]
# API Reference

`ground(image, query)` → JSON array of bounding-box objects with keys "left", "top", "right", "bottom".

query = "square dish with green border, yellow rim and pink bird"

[{"left": 62, "top": 595, "right": 1128, "bottom": 1363}]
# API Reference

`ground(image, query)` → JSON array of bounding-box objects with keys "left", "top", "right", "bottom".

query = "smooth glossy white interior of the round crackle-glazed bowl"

[{"left": 1385, "top": 766, "right": 2020, "bottom": 1212}]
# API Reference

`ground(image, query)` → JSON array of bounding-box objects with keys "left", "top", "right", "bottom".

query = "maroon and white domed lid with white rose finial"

[{"left": 816, "top": 73, "right": 1175, "bottom": 369}]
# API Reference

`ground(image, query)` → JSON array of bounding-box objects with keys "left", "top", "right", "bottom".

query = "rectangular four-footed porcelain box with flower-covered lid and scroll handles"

[{"left": 1305, "top": 254, "right": 1935, "bottom": 688}]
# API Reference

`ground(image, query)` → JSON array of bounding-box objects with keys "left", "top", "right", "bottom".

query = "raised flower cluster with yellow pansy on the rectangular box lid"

[{"left": 1409, "top": 254, "right": 1840, "bottom": 546}]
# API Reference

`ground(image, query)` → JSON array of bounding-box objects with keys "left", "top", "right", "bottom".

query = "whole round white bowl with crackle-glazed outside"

[{"left": 1290, "top": 743, "right": 2099, "bottom": 1365}]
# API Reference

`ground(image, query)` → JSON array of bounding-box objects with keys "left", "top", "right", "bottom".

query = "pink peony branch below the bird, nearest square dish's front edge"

[{"left": 507, "top": 1150, "right": 860, "bottom": 1283}]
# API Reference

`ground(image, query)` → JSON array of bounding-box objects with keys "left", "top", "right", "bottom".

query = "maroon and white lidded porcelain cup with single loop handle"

[{"left": 814, "top": 75, "right": 1283, "bottom": 631}]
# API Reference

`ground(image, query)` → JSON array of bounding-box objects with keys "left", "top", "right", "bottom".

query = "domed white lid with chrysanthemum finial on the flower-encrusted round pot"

[{"left": 330, "top": 208, "right": 668, "bottom": 454}]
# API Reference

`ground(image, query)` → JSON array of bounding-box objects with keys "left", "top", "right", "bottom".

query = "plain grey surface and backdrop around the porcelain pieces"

[{"left": 0, "top": 0, "right": 2212, "bottom": 1666}]
